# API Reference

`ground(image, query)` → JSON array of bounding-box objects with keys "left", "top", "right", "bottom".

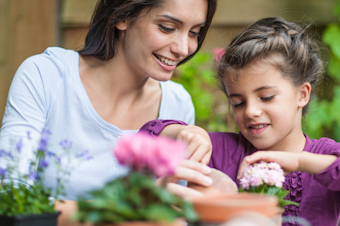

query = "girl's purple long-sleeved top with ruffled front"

[{"left": 141, "top": 120, "right": 340, "bottom": 226}]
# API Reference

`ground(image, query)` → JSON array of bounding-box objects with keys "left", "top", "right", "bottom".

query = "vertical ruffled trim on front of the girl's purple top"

[{"left": 282, "top": 172, "right": 303, "bottom": 226}]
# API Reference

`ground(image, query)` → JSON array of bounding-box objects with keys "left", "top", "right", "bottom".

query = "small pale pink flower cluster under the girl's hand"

[{"left": 240, "top": 162, "right": 285, "bottom": 190}]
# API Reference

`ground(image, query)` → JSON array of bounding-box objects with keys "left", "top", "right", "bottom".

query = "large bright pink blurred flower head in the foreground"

[{"left": 113, "top": 133, "right": 186, "bottom": 176}]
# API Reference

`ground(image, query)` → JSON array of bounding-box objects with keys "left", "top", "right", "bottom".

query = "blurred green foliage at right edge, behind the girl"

[{"left": 303, "top": 0, "right": 340, "bottom": 142}]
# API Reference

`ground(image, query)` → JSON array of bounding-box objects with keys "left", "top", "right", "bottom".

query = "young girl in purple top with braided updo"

[{"left": 142, "top": 18, "right": 340, "bottom": 225}]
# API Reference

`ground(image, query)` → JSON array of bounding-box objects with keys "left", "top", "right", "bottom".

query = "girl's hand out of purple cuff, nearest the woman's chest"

[{"left": 160, "top": 124, "right": 212, "bottom": 165}]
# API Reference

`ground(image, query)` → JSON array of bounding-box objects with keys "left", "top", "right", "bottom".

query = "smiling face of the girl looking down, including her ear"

[{"left": 224, "top": 62, "right": 310, "bottom": 151}]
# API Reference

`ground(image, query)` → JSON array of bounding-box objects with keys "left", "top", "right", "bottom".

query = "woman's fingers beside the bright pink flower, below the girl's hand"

[{"left": 155, "top": 160, "right": 212, "bottom": 199}]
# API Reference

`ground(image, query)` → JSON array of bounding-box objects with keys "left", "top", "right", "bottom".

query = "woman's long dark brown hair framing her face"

[{"left": 79, "top": 0, "right": 217, "bottom": 64}]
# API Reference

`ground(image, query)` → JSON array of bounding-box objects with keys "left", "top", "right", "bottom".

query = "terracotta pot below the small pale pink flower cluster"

[{"left": 192, "top": 193, "right": 278, "bottom": 222}]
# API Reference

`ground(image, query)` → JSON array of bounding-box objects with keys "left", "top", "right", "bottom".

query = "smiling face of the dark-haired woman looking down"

[{"left": 116, "top": 0, "right": 208, "bottom": 81}]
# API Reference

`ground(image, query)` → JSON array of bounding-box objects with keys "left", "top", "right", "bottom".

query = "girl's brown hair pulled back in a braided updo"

[{"left": 217, "top": 18, "right": 322, "bottom": 114}]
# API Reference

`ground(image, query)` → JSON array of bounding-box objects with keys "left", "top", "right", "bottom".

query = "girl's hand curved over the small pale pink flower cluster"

[{"left": 237, "top": 151, "right": 302, "bottom": 179}]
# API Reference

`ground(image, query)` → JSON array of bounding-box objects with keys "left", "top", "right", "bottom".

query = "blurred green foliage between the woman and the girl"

[{"left": 173, "top": 52, "right": 228, "bottom": 132}]
